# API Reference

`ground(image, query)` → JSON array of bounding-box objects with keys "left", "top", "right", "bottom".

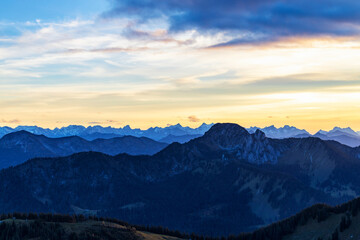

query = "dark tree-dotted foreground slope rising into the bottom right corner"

[{"left": 236, "top": 198, "right": 360, "bottom": 240}]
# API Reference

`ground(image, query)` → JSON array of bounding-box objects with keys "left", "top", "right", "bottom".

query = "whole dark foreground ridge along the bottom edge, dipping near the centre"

[{"left": 0, "top": 198, "right": 360, "bottom": 240}]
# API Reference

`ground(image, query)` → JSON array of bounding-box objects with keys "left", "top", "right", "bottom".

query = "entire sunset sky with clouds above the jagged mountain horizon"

[{"left": 0, "top": 0, "right": 360, "bottom": 132}]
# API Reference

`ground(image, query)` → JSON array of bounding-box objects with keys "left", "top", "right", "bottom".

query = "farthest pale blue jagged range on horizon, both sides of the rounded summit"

[{"left": 0, "top": 123, "right": 360, "bottom": 147}]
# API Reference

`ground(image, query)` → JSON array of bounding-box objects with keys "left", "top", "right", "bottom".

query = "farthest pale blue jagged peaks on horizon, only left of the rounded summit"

[{"left": 0, "top": 123, "right": 213, "bottom": 142}]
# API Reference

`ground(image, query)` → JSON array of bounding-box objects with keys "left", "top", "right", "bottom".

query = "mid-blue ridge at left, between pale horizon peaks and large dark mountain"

[{"left": 0, "top": 131, "right": 167, "bottom": 169}]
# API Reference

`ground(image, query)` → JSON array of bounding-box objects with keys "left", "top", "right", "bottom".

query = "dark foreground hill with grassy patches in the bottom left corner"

[{"left": 0, "top": 214, "right": 180, "bottom": 240}]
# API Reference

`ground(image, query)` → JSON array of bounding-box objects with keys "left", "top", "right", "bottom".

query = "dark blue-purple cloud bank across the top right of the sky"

[{"left": 104, "top": 0, "right": 360, "bottom": 45}]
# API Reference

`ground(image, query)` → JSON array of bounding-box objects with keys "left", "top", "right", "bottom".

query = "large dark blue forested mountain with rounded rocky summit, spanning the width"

[{"left": 0, "top": 124, "right": 360, "bottom": 235}]
